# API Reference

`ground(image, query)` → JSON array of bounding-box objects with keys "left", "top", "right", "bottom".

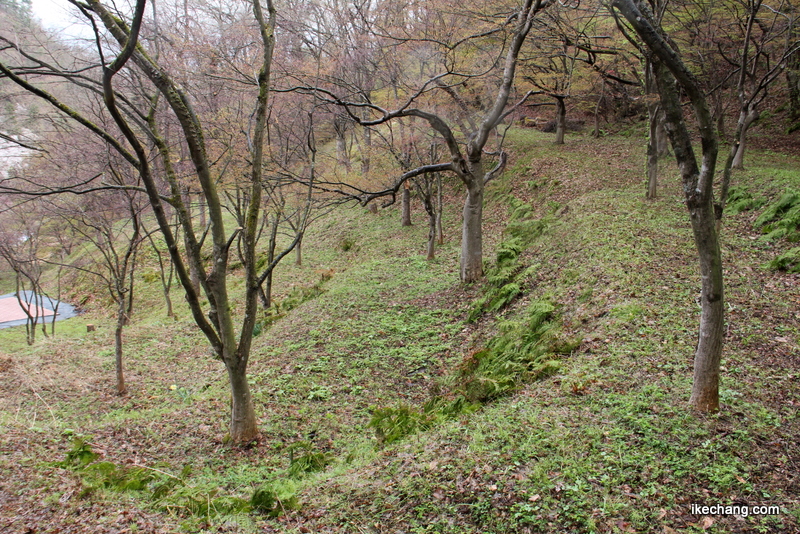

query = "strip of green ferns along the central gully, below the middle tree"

[{"left": 368, "top": 197, "right": 577, "bottom": 446}]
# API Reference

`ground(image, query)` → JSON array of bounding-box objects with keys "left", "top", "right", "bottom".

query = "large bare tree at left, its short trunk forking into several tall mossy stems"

[{"left": 0, "top": 0, "right": 276, "bottom": 443}]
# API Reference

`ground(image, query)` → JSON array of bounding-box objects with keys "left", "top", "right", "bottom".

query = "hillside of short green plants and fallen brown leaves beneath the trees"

[{"left": 0, "top": 127, "right": 800, "bottom": 533}]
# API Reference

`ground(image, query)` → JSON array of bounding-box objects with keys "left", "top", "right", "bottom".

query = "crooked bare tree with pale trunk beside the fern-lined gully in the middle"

[{"left": 300, "top": 0, "right": 551, "bottom": 283}]
